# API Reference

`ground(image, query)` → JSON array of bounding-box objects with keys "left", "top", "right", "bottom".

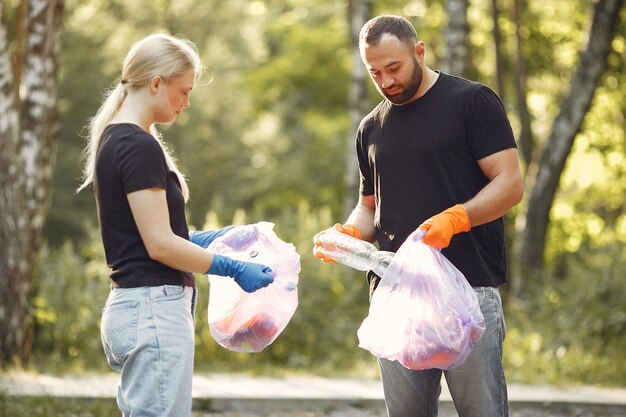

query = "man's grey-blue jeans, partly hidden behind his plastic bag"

[{"left": 379, "top": 287, "right": 509, "bottom": 417}]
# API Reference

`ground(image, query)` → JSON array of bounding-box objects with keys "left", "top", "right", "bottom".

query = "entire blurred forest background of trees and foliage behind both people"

[{"left": 0, "top": 0, "right": 626, "bottom": 386}]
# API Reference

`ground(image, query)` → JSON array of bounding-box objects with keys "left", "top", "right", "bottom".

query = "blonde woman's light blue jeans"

[{"left": 100, "top": 285, "right": 196, "bottom": 417}]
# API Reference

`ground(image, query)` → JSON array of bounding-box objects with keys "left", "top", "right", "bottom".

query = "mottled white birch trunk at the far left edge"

[{"left": 0, "top": 0, "right": 63, "bottom": 364}]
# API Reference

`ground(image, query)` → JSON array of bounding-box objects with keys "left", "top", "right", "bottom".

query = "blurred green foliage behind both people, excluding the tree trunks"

[{"left": 31, "top": 0, "right": 626, "bottom": 386}]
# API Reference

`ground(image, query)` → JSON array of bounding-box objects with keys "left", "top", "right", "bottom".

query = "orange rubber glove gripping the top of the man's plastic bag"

[{"left": 419, "top": 204, "right": 472, "bottom": 249}]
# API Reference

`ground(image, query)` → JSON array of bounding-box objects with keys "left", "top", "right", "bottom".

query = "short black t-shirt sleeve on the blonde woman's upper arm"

[{"left": 116, "top": 134, "right": 168, "bottom": 194}]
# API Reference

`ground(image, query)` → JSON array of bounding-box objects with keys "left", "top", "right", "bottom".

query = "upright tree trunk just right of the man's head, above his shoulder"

[{"left": 441, "top": 0, "right": 469, "bottom": 77}]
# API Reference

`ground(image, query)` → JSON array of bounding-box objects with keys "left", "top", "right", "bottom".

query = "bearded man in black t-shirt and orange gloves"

[{"left": 314, "top": 16, "right": 523, "bottom": 417}]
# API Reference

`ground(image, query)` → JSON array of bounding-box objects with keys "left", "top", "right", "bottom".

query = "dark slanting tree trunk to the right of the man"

[{"left": 518, "top": 0, "right": 624, "bottom": 282}]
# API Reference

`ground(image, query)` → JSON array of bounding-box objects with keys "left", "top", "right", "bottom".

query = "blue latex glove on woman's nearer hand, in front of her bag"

[{"left": 207, "top": 255, "right": 274, "bottom": 292}]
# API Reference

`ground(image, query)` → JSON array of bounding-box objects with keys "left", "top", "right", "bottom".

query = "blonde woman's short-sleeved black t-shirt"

[{"left": 95, "top": 123, "right": 195, "bottom": 288}]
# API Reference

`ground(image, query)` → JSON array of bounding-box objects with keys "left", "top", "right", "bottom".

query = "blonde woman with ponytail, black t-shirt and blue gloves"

[{"left": 79, "top": 34, "right": 273, "bottom": 417}]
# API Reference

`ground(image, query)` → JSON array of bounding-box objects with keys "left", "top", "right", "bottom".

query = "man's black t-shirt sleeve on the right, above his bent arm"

[{"left": 463, "top": 86, "right": 517, "bottom": 160}]
